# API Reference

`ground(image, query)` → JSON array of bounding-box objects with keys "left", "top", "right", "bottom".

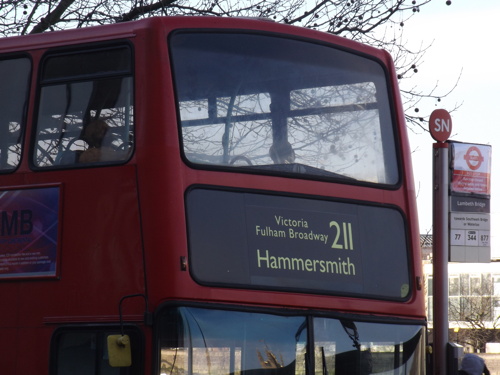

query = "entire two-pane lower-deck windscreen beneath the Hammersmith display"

[{"left": 159, "top": 307, "right": 424, "bottom": 375}]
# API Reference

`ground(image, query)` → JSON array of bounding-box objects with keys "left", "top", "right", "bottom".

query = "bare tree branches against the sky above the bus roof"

[{"left": 0, "top": 0, "right": 451, "bottom": 126}]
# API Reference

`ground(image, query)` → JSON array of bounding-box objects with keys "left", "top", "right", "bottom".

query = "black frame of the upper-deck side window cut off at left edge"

[{"left": 0, "top": 52, "right": 34, "bottom": 175}]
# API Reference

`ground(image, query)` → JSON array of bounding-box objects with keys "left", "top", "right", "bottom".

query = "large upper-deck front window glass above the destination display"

[{"left": 170, "top": 33, "right": 399, "bottom": 185}]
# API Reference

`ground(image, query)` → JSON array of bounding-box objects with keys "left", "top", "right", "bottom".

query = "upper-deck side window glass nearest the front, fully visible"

[{"left": 33, "top": 46, "right": 134, "bottom": 168}]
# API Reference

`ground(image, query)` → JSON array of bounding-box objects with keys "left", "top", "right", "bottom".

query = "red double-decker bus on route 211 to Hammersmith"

[{"left": 0, "top": 17, "right": 426, "bottom": 375}]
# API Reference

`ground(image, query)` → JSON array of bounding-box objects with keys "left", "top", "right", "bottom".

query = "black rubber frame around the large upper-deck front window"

[{"left": 167, "top": 28, "right": 406, "bottom": 191}]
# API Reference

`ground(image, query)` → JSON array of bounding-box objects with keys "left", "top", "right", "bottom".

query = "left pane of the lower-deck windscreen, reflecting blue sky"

[{"left": 160, "top": 307, "right": 306, "bottom": 375}]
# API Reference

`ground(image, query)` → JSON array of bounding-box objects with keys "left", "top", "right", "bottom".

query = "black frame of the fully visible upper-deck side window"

[{"left": 28, "top": 38, "right": 137, "bottom": 171}]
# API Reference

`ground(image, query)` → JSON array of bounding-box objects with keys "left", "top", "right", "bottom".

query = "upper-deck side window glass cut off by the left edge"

[{"left": 0, "top": 57, "right": 31, "bottom": 173}]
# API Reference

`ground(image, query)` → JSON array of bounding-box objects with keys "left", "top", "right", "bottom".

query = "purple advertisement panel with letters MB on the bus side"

[{"left": 0, "top": 187, "right": 59, "bottom": 279}]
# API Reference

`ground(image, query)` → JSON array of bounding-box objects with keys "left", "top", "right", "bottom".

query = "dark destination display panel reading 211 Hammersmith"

[{"left": 187, "top": 189, "right": 409, "bottom": 299}]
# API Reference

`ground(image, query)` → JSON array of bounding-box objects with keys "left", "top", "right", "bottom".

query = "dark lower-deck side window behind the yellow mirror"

[{"left": 50, "top": 327, "right": 142, "bottom": 375}]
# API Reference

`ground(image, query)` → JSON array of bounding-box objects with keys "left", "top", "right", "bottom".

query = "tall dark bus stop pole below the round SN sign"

[{"left": 432, "top": 142, "right": 449, "bottom": 375}]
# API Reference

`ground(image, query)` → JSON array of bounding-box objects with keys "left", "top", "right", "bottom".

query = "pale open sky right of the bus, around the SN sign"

[{"left": 403, "top": 0, "right": 500, "bottom": 257}]
